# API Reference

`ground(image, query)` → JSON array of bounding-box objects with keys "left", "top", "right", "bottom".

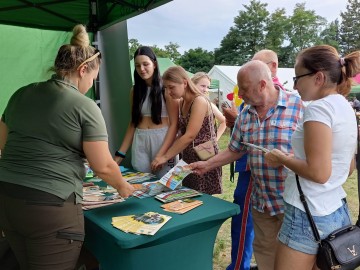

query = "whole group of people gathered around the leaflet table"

[{"left": 0, "top": 25, "right": 360, "bottom": 270}]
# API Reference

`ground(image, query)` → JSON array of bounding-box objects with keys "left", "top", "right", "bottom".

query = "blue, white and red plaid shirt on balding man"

[{"left": 229, "top": 90, "right": 303, "bottom": 216}]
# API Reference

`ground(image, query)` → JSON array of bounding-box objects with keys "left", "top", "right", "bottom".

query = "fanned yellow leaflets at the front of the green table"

[{"left": 111, "top": 212, "right": 171, "bottom": 235}]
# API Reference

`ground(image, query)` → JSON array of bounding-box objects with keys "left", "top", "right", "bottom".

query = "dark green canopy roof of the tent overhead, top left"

[{"left": 0, "top": 0, "right": 171, "bottom": 32}]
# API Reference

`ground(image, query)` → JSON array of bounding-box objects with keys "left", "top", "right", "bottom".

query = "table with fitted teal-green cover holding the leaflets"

[{"left": 84, "top": 194, "right": 240, "bottom": 270}]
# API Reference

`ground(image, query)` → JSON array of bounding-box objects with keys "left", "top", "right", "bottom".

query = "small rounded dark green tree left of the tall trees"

[{"left": 179, "top": 47, "right": 215, "bottom": 73}]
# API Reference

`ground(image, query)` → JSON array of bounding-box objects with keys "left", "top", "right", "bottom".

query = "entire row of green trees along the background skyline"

[{"left": 129, "top": 0, "right": 354, "bottom": 69}]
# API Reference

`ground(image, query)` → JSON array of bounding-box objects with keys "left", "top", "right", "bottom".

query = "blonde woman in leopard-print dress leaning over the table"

[{"left": 152, "top": 66, "right": 222, "bottom": 194}]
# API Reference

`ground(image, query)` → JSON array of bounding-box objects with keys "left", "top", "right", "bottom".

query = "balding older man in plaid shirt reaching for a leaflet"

[{"left": 191, "top": 60, "right": 303, "bottom": 270}]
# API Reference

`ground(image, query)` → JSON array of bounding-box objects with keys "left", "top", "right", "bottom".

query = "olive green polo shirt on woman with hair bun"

[{"left": 0, "top": 77, "right": 108, "bottom": 202}]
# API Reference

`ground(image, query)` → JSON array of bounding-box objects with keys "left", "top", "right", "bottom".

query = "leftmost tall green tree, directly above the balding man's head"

[{"left": 215, "top": 0, "right": 269, "bottom": 65}]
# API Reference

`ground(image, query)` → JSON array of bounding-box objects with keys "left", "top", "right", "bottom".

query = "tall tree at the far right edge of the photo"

[{"left": 340, "top": 0, "right": 360, "bottom": 54}]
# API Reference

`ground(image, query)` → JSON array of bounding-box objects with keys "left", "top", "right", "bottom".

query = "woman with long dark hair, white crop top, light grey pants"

[{"left": 115, "top": 46, "right": 179, "bottom": 177}]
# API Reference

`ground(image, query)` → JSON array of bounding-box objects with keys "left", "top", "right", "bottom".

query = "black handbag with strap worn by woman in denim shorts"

[{"left": 296, "top": 174, "right": 360, "bottom": 270}]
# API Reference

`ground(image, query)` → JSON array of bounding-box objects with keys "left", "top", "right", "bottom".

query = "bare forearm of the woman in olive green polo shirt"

[{"left": 83, "top": 141, "right": 134, "bottom": 198}]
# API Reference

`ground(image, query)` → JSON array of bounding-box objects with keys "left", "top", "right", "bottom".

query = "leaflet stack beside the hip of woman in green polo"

[{"left": 82, "top": 185, "right": 124, "bottom": 210}]
